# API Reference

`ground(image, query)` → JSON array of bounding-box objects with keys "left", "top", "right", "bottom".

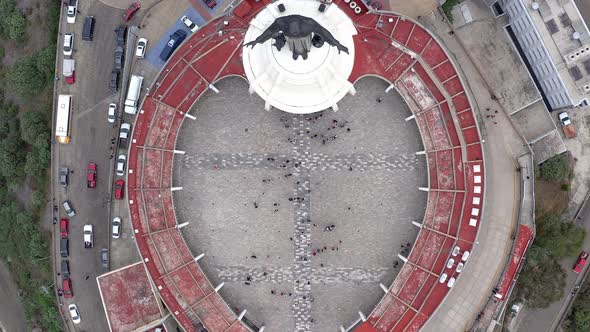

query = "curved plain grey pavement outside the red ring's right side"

[{"left": 422, "top": 6, "right": 529, "bottom": 332}]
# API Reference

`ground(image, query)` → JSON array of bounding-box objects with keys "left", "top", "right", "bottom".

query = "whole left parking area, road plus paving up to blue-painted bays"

[{"left": 52, "top": 0, "right": 234, "bottom": 331}]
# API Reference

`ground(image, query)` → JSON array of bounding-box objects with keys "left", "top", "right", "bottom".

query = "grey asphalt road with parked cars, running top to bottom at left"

[{"left": 52, "top": 1, "right": 131, "bottom": 331}]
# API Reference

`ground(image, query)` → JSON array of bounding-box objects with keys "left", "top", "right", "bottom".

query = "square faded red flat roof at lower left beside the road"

[{"left": 96, "top": 262, "right": 163, "bottom": 332}]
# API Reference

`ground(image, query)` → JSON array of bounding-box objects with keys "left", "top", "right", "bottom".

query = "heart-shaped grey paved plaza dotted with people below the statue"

[{"left": 174, "top": 78, "right": 427, "bottom": 331}]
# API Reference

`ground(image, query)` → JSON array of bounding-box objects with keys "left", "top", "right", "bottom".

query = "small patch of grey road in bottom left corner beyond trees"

[{"left": 0, "top": 261, "right": 27, "bottom": 332}]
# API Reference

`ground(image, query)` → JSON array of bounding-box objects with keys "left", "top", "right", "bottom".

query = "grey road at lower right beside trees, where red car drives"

[{"left": 514, "top": 196, "right": 590, "bottom": 332}]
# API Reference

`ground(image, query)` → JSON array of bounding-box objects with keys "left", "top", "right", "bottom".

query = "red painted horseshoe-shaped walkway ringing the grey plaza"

[{"left": 128, "top": 0, "right": 492, "bottom": 331}]
